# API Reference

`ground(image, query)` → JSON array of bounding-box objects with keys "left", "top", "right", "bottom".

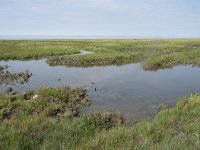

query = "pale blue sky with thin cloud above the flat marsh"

[{"left": 0, "top": 0, "right": 200, "bottom": 38}]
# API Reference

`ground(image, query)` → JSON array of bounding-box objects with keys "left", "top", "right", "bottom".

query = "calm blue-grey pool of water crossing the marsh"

[{"left": 0, "top": 59, "right": 200, "bottom": 120}]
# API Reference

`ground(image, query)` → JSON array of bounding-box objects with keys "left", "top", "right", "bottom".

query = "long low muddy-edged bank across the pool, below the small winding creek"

[{"left": 46, "top": 54, "right": 138, "bottom": 67}]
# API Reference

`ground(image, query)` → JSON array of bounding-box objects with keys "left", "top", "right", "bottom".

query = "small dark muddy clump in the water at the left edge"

[{"left": 0, "top": 65, "right": 32, "bottom": 85}]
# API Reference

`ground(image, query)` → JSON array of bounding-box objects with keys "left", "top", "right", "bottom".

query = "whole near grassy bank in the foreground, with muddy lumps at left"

[{"left": 0, "top": 88, "right": 200, "bottom": 150}]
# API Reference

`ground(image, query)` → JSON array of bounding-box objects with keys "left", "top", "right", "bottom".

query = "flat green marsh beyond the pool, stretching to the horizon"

[{"left": 0, "top": 39, "right": 200, "bottom": 70}]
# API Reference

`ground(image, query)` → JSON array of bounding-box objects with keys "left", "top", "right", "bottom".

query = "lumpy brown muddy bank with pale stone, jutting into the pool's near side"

[{"left": 0, "top": 87, "right": 91, "bottom": 120}]
